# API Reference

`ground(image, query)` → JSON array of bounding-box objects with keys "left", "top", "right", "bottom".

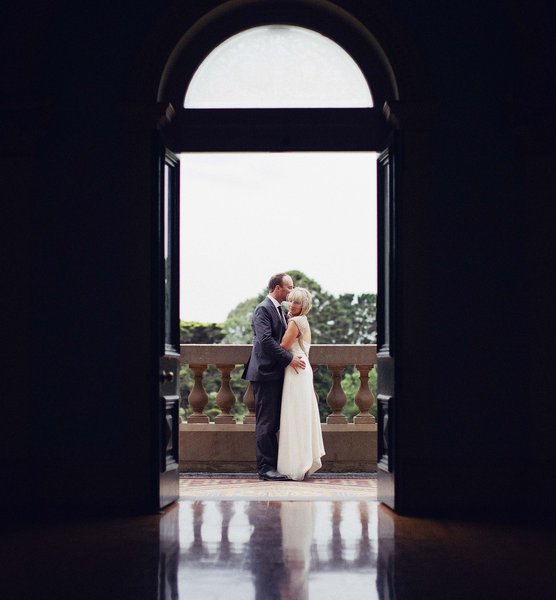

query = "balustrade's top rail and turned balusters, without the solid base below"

[{"left": 181, "top": 344, "right": 376, "bottom": 425}]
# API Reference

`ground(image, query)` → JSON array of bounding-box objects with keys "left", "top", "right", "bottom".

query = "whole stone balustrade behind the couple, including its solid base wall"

[{"left": 180, "top": 344, "right": 376, "bottom": 472}]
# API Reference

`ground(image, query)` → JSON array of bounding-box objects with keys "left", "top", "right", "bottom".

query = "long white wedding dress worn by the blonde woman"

[{"left": 278, "top": 316, "right": 324, "bottom": 481}]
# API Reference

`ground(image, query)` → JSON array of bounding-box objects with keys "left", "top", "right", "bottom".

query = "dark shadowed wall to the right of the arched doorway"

[{"left": 386, "top": 2, "right": 556, "bottom": 514}]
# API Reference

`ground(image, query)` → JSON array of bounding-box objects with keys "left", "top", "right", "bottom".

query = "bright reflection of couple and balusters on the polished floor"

[{"left": 175, "top": 501, "right": 378, "bottom": 600}]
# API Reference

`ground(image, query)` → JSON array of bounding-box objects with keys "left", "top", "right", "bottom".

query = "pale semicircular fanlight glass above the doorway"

[{"left": 184, "top": 25, "right": 373, "bottom": 108}]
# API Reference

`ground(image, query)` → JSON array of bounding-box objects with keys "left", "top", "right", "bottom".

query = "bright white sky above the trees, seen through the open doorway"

[{"left": 180, "top": 152, "right": 377, "bottom": 323}]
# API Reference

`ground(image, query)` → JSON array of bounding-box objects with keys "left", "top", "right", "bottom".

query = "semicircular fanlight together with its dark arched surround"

[{"left": 158, "top": 0, "right": 398, "bottom": 108}]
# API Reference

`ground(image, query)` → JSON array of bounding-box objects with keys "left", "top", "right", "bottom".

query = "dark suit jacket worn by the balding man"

[{"left": 243, "top": 296, "right": 293, "bottom": 381}]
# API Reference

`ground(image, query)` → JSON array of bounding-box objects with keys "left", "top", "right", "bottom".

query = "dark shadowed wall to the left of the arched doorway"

[{"left": 2, "top": 2, "right": 170, "bottom": 510}]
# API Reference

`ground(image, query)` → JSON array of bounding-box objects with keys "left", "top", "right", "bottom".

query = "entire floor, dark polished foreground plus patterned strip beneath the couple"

[{"left": 0, "top": 478, "right": 556, "bottom": 600}]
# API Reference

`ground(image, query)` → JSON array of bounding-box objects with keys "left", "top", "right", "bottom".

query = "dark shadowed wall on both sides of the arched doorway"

[{"left": 1, "top": 0, "right": 556, "bottom": 513}]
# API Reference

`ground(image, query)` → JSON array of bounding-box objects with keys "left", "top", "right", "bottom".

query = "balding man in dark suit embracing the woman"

[{"left": 243, "top": 273, "right": 305, "bottom": 481}]
